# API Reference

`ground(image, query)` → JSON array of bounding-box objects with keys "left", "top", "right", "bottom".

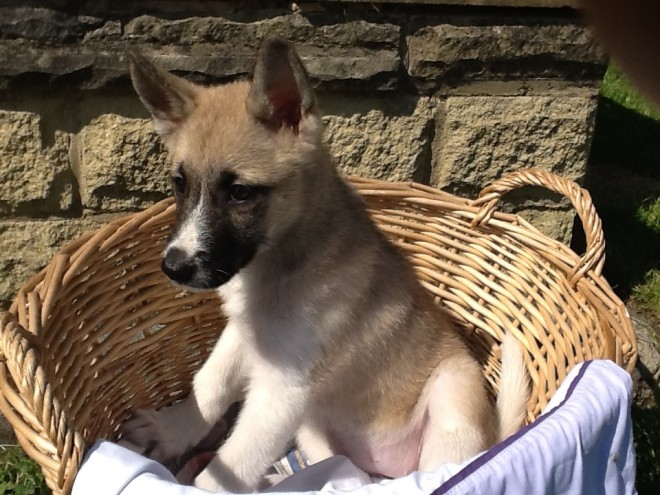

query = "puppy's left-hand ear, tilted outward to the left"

[{"left": 126, "top": 50, "right": 196, "bottom": 138}]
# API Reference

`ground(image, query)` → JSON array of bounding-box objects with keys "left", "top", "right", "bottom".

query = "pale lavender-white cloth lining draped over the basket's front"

[{"left": 73, "top": 360, "right": 636, "bottom": 495}]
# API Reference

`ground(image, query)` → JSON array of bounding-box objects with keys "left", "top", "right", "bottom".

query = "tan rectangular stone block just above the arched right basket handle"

[{"left": 431, "top": 96, "right": 596, "bottom": 196}]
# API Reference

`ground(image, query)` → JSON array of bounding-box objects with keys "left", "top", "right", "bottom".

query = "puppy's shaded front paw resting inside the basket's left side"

[{"left": 119, "top": 409, "right": 188, "bottom": 465}]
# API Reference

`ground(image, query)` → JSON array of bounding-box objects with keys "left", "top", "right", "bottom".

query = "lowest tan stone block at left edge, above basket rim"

[{"left": 0, "top": 218, "right": 107, "bottom": 309}]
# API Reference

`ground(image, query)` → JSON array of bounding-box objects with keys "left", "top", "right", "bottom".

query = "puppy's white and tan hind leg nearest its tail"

[{"left": 419, "top": 356, "right": 497, "bottom": 471}]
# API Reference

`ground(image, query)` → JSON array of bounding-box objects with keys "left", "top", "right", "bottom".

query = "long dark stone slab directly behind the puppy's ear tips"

[{"left": 124, "top": 15, "right": 400, "bottom": 89}]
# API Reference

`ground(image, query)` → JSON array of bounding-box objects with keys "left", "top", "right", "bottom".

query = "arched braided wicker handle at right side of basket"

[{"left": 472, "top": 168, "right": 605, "bottom": 285}]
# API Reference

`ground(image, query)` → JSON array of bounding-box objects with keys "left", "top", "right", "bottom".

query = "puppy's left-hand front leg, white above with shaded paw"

[{"left": 121, "top": 325, "right": 242, "bottom": 464}]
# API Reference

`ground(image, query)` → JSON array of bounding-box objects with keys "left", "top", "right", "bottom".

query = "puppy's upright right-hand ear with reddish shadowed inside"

[{"left": 246, "top": 38, "right": 316, "bottom": 132}]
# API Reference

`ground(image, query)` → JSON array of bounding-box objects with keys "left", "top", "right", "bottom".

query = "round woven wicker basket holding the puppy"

[{"left": 0, "top": 170, "right": 637, "bottom": 494}]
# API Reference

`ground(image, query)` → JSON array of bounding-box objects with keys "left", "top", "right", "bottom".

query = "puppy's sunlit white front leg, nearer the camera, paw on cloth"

[{"left": 195, "top": 368, "right": 308, "bottom": 493}]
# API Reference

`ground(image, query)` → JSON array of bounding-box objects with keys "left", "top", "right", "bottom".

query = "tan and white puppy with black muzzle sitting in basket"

[{"left": 122, "top": 38, "right": 528, "bottom": 492}]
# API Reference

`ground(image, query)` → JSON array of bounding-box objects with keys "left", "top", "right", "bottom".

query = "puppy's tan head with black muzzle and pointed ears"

[{"left": 129, "top": 39, "right": 322, "bottom": 289}]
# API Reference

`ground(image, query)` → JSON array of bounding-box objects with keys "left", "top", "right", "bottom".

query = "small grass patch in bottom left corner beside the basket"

[{"left": 0, "top": 446, "right": 50, "bottom": 495}]
